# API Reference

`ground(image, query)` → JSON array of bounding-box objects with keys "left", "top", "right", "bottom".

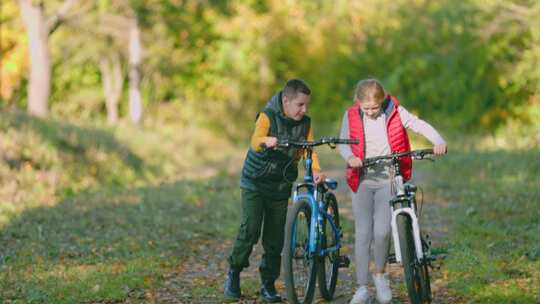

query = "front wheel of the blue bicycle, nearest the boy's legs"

[{"left": 283, "top": 200, "right": 317, "bottom": 303}]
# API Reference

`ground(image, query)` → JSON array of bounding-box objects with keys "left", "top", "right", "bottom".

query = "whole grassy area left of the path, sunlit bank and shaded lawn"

[{"left": 0, "top": 113, "right": 243, "bottom": 303}]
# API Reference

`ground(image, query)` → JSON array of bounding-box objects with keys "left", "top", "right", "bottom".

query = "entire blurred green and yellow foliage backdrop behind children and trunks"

[{"left": 6, "top": 0, "right": 540, "bottom": 139}]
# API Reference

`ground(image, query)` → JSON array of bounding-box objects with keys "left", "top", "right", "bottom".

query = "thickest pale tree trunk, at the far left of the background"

[{"left": 19, "top": 0, "right": 51, "bottom": 117}]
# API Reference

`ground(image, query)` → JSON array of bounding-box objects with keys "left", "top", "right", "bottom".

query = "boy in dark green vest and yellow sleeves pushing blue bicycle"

[{"left": 225, "top": 79, "right": 325, "bottom": 303}]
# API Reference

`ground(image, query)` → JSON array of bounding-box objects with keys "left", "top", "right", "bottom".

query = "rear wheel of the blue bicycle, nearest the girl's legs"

[{"left": 317, "top": 193, "right": 340, "bottom": 301}]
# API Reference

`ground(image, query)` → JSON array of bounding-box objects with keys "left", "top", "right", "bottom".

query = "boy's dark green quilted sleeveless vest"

[{"left": 240, "top": 92, "right": 310, "bottom": 200}]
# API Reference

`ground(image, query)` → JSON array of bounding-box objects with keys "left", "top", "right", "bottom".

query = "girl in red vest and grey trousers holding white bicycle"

[{"left": 339, "top": 79, "right": 447, "bottom": 304}]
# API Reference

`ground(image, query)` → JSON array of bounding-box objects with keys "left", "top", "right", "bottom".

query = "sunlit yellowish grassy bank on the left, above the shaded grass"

[{"left": 0, "top": 112, "right": 238, "bottom": 222}]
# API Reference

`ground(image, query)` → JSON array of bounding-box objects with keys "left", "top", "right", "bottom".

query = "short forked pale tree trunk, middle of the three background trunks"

[{"left": 99, "top": 54, "right": 124, "bottom": 125}]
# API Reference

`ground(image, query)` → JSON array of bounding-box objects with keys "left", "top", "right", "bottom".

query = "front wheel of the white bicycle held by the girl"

[{"left": 397, "top": 214, "right": 431, "bottom": 304}]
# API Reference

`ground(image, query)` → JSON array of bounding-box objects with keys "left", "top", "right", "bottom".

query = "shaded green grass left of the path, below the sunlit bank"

[{"left": 0, "top": 176, "right": 240, "bottom": 303}]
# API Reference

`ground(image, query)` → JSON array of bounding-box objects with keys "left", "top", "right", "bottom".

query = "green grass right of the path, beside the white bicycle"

[{"left": 420, "top": 149, "right": 540, "bottom": 303}]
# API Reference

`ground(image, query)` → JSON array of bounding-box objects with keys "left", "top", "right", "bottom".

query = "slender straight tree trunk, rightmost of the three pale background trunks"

[{"left": 129, "top": 16, "right": 142, "bottom": 124}]
